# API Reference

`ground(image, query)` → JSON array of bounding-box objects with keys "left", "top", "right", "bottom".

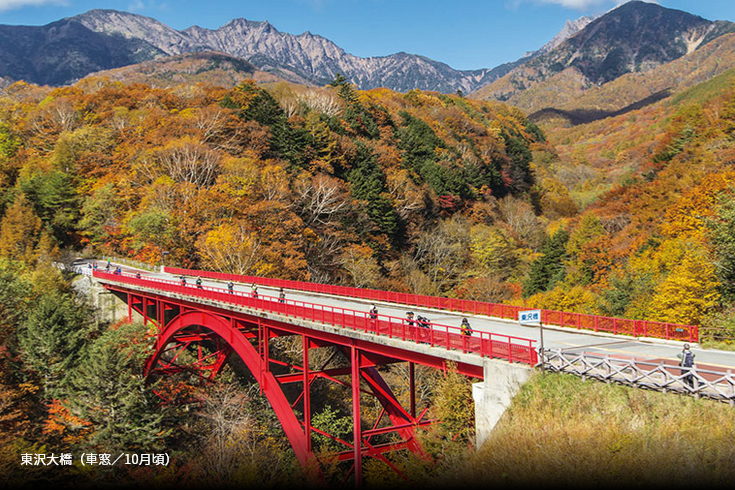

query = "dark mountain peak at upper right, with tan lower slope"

[{"left": 473, "top": 1, "right": 735, "bottom": 111}]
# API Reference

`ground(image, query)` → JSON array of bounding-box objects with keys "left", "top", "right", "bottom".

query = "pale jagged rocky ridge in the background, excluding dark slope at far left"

[{"left": 71, "top": 10, "right": 507, "bottom": 92}]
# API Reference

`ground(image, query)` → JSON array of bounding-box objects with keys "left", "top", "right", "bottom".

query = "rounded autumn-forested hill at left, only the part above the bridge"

[{"left": 0, "top": 79, "right": 548, "bottom": 294}]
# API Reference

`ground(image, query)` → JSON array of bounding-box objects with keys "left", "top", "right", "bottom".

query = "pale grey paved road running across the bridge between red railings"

[{"left": 85, "top": 261, "right": 735, "bottom": 370}]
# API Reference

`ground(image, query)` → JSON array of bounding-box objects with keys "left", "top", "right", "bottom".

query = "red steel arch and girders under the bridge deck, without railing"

[{"left": 106, "top": 285, "right": 454, "bottom": 481}]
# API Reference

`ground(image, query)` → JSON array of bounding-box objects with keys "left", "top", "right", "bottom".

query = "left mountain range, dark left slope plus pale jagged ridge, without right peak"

[{"left": 0, "top": 9, "right": 588, "bottom": 93}]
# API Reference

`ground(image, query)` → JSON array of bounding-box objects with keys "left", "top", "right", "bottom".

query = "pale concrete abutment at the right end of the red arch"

[{"left": 472, "top": 360, "right": 533, "bottom": 449}]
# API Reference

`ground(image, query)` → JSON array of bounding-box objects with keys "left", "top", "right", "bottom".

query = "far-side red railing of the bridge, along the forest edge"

[{"left": 164, "top": 267, "right": 699, "bottom": 342}]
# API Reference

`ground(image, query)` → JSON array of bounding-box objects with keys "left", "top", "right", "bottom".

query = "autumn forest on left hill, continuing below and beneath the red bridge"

[{"left": 0, "top": 78, "right": 549, "bottom": 488}]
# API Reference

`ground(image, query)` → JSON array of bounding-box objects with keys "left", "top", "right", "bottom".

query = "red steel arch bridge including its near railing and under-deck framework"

[{"left": 93, "top": 270, "right": 538, "bottom": 478}]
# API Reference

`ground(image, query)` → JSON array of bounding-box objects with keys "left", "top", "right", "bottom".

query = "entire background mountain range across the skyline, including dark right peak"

[{"left": 0, "top": 1, "right": 735, "bottom": 97}]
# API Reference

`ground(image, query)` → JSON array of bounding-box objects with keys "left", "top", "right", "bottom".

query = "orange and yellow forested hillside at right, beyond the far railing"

[{"left": 529, "top": 67, "right": 734, "bottom": 338}]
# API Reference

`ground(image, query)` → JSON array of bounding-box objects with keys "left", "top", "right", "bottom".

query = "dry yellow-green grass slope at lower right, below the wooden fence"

[{"left": 428, "top": 373, "right": 735, "bottom": 488}]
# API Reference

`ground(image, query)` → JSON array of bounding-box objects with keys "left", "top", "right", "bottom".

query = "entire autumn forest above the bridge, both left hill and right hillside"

[{"left": 0, "top": 70, "right": 732, "bottom": 334}]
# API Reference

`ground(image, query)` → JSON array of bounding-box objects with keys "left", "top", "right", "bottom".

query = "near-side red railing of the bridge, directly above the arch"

[{"left": 92, "top": 271, "right": 538, "bottom": 366}]
